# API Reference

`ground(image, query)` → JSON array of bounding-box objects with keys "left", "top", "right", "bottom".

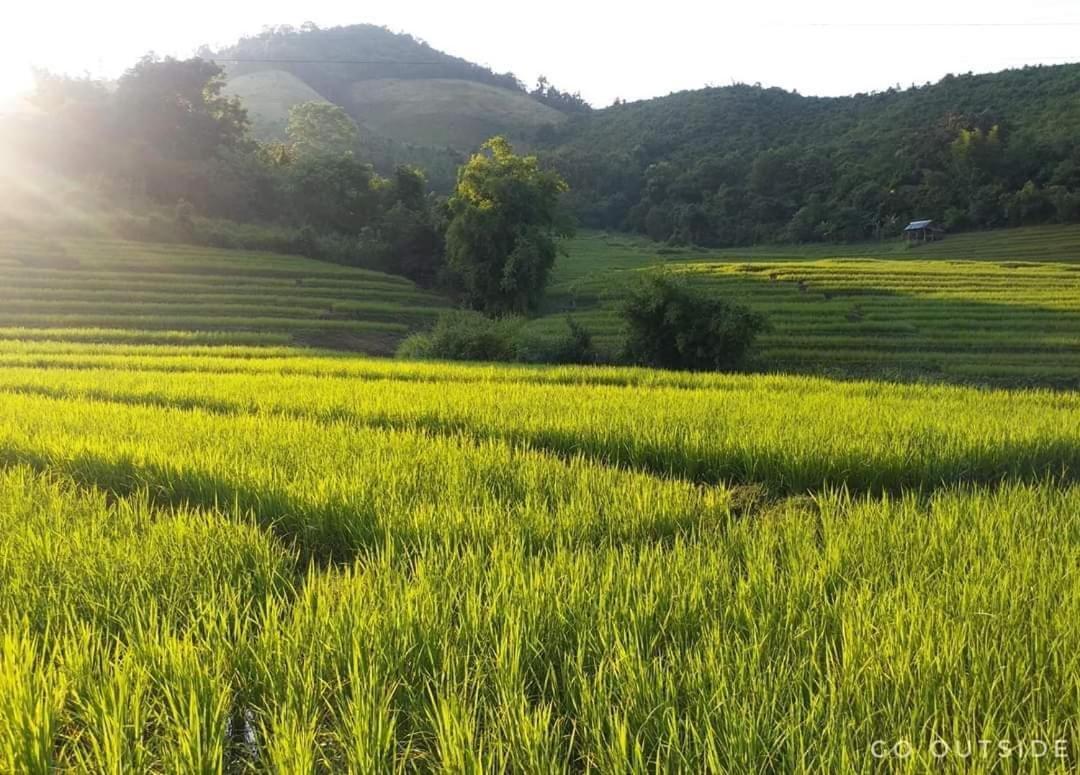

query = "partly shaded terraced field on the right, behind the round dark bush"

[{"left": 534, "top": 227, "right": 1080, "bottom": 389}]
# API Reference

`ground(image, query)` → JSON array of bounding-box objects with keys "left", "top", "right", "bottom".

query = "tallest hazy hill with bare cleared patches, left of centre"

[{"left": 207, "top": 25, "right": 566, "bottom": 151}]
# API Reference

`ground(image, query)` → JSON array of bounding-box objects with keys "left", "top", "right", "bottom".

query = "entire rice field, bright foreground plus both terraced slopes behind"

[{"left": 0, "top": 228, "right": 1080, "bottom": 775}]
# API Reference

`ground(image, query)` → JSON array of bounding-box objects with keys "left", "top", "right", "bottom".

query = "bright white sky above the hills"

[{"left": 0, "top": 0, "right": 1080, "bottom": 107}]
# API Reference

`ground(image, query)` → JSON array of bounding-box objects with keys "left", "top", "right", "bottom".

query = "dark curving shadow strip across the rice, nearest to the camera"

[{"left": 0, "top": 436, "right": 725, "bottom": 572}]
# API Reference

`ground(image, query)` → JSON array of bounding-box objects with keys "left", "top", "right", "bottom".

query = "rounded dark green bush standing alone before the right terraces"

[{"left": 619, "top": 274, "right": 766, "bottom": 371}]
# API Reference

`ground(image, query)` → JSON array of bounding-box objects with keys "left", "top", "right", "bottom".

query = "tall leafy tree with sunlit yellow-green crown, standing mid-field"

[{"left": 446, "top": 137, "right": 571, "bottom": 314}]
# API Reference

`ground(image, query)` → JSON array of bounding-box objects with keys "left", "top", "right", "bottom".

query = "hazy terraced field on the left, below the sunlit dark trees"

[{"left": 0, "top": 233, "right": 447, "bottom": 353}]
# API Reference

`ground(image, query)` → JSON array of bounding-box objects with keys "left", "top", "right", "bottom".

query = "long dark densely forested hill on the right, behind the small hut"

[{"left": 542, "top": 65, "right": 1080, "bottom": 245}]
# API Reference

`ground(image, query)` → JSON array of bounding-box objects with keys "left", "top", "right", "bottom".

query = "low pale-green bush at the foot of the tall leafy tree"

[{"left": 397, "top": 310, "right": 522, "bottom": 361}]
